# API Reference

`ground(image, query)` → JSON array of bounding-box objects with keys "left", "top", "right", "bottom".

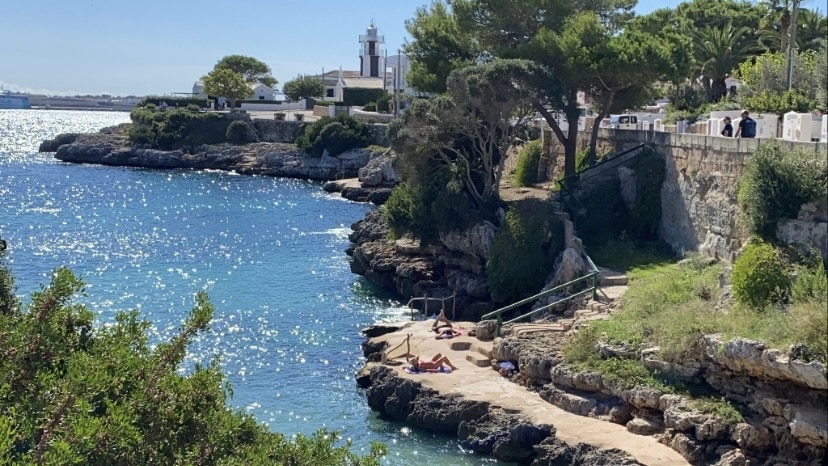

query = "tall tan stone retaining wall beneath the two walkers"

[{"left": 542, "top": 129, "right": 828, "bottom": 261}]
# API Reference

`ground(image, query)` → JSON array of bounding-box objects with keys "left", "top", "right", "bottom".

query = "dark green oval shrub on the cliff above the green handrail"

[{"left": 486, "top": 199, "right": 563, "bottom": 302}]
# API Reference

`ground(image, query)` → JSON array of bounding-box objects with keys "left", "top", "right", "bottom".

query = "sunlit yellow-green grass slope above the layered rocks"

[{"left": 567, "top": 248, "right": 828, "bottom": 368}]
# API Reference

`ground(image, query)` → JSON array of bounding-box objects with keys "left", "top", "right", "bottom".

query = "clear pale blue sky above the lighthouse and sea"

[{"left": 0, "top": 0, "right": 680, "bottom": 95}]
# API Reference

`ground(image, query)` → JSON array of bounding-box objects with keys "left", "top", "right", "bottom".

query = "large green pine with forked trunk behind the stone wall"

[{"left": 406, "top": 0, "right": 687, "bottom": 178}]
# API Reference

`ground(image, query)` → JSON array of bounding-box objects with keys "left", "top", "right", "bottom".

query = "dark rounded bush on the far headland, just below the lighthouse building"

[{"left": 296, "top": 114, "right": 371, "bottom": 157}]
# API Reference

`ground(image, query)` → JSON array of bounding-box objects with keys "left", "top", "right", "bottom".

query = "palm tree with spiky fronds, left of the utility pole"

[{"left": 693, "top": 21, "right": 760, "bottom": 102}]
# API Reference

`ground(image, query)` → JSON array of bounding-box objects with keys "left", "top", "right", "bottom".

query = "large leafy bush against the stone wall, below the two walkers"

[{"left": 737, "top": 141, "right": 828, "bottom": 242}]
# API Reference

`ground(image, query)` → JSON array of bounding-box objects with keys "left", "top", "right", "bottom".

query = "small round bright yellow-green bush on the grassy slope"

[{"left": 730, "top": 241, "right": 790, "bottom": 308}]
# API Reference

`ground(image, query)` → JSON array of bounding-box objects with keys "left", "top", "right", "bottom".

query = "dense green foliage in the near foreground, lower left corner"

[{"left": 0, "top": 267, "right": 385, "bottom": 466}]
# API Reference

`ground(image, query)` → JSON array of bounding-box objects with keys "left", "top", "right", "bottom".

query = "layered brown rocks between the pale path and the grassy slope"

[{"left": 492, "top": 334, "right": 828, "bottom": 465}]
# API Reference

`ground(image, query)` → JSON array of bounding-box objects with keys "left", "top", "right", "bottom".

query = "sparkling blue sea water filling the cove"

[{"left": 0, "top": 110, "right": 505, "bottom": 466}]
